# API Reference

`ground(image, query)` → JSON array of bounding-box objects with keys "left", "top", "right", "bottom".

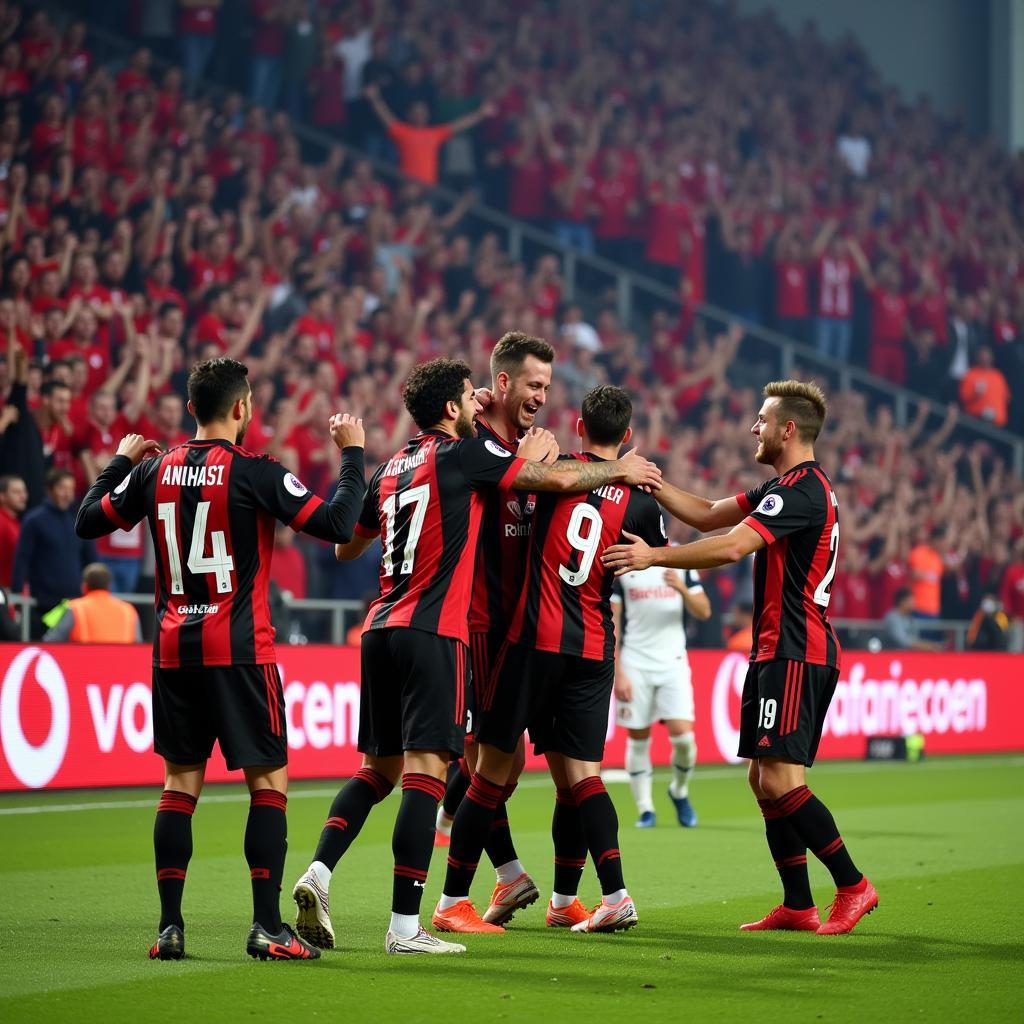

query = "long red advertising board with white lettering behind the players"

[{"left": 0, "top": 644, "right": 1024, "bottom": 791}]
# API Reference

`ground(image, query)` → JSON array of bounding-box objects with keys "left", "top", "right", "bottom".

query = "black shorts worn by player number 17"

[{"left": 359, "top": 627, "right": 469, "bottom": 758}]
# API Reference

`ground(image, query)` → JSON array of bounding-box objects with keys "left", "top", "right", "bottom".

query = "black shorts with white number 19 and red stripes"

[{"left": 738, "top": 658, "right": 839, "bottom": 767}]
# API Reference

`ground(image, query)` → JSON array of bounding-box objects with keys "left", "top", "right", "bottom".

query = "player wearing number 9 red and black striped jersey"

[{"left": 433, "top": 385, "right": 665, "bottom": 932}]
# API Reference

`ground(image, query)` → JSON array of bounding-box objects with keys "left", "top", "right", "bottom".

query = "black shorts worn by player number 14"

[{"left": 153, "top": 665, "right": 288, "bottom": 771}]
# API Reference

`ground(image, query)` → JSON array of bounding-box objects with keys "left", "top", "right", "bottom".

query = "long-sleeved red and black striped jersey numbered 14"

[{"left": 78, "top": 440, "right": 364, "bottom": 669}]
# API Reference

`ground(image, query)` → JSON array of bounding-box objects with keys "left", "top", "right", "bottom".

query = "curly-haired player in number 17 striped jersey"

[{"left": 294, "top": 359, "right": 660, "bottom": 953}]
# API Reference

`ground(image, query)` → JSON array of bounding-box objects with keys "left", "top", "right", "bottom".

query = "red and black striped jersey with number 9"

[{"left": 509, "top": 453, "right": 666, "bottom": 660}]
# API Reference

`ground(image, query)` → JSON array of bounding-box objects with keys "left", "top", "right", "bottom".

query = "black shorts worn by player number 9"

[{"left": 476, "top": 644, "right": 615, "bottom": 761}]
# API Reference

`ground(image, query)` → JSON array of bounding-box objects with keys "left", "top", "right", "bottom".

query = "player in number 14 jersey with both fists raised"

[{"left": 77, "top": 358, "right": 365, "bottom": 959}]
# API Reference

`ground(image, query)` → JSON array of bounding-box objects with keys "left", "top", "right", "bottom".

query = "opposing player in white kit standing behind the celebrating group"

[{"left": 611, "top": 565, "right": 711, "bottom": 828}]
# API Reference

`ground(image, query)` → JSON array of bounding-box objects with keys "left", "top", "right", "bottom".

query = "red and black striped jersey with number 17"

[{"left": 355, "top": 430, "right": 525, "bottom": 644}]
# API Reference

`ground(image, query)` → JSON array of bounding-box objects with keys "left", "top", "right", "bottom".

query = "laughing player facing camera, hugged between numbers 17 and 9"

[{"left": 435, "top": 331, "right": 555, "bottom": 925}]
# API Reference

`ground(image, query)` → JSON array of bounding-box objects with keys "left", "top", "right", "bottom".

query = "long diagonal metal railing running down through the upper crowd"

[{"left": 59, "top": 3, "right": 1024, "bottom": 476}]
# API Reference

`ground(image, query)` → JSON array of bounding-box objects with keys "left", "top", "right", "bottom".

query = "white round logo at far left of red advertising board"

[{"left": 0, "top": 647, "right": 71, "bottom": 790}]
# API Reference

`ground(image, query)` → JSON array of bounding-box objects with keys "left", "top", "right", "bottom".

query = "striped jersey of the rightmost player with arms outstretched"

[{"left": 736, "top": 462, "right": 842, "bottom": 669}]
